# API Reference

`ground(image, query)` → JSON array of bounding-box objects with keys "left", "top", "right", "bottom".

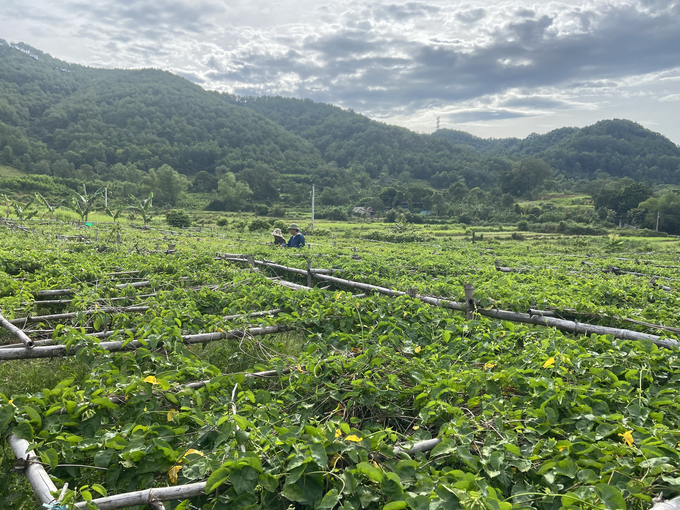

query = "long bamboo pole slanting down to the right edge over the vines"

[{"left": 314, "top": 274, "right": 680, "bottom": 349}]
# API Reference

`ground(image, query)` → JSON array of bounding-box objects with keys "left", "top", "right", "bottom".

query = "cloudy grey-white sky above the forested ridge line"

[{"left": 0, "top": 0, "right": 680, "bottom": 144}]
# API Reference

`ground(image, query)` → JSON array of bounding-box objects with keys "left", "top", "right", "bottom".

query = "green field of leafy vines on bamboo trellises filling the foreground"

[{"left": 0, "top": 221, "right": 680, "bottom": 510}]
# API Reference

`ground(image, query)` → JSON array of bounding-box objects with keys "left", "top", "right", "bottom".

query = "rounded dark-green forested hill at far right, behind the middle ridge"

[{"left": 433, "top": 119, "right": 680, "bottom": 183}]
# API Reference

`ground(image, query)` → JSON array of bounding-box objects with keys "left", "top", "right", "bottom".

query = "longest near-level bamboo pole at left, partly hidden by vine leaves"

[{"left": 0, "top": 325, "right": 290, "bottom": 360}]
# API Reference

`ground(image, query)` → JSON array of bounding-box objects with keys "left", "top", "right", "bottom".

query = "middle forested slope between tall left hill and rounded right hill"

[{"left": 231, "top": 95, "right": 502, "bottom": 188}]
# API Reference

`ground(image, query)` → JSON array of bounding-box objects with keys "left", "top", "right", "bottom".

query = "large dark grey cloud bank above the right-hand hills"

[{"left": 214, "top": 0, "right": 680, "bottom": 115}]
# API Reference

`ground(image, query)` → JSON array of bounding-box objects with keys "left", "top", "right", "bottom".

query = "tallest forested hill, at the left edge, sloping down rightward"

[{"left": 0, "top": 40, "right": 322, "bottom": 174}]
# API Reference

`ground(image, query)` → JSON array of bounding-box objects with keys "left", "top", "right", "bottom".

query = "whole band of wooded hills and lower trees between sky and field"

[{"left": 0, "top": 39, "right": 680, "bottom": 234}]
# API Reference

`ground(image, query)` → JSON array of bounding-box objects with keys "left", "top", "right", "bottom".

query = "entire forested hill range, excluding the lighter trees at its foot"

[{"left": 0, "top": 39, "right": 680, "bottom": 197}]
